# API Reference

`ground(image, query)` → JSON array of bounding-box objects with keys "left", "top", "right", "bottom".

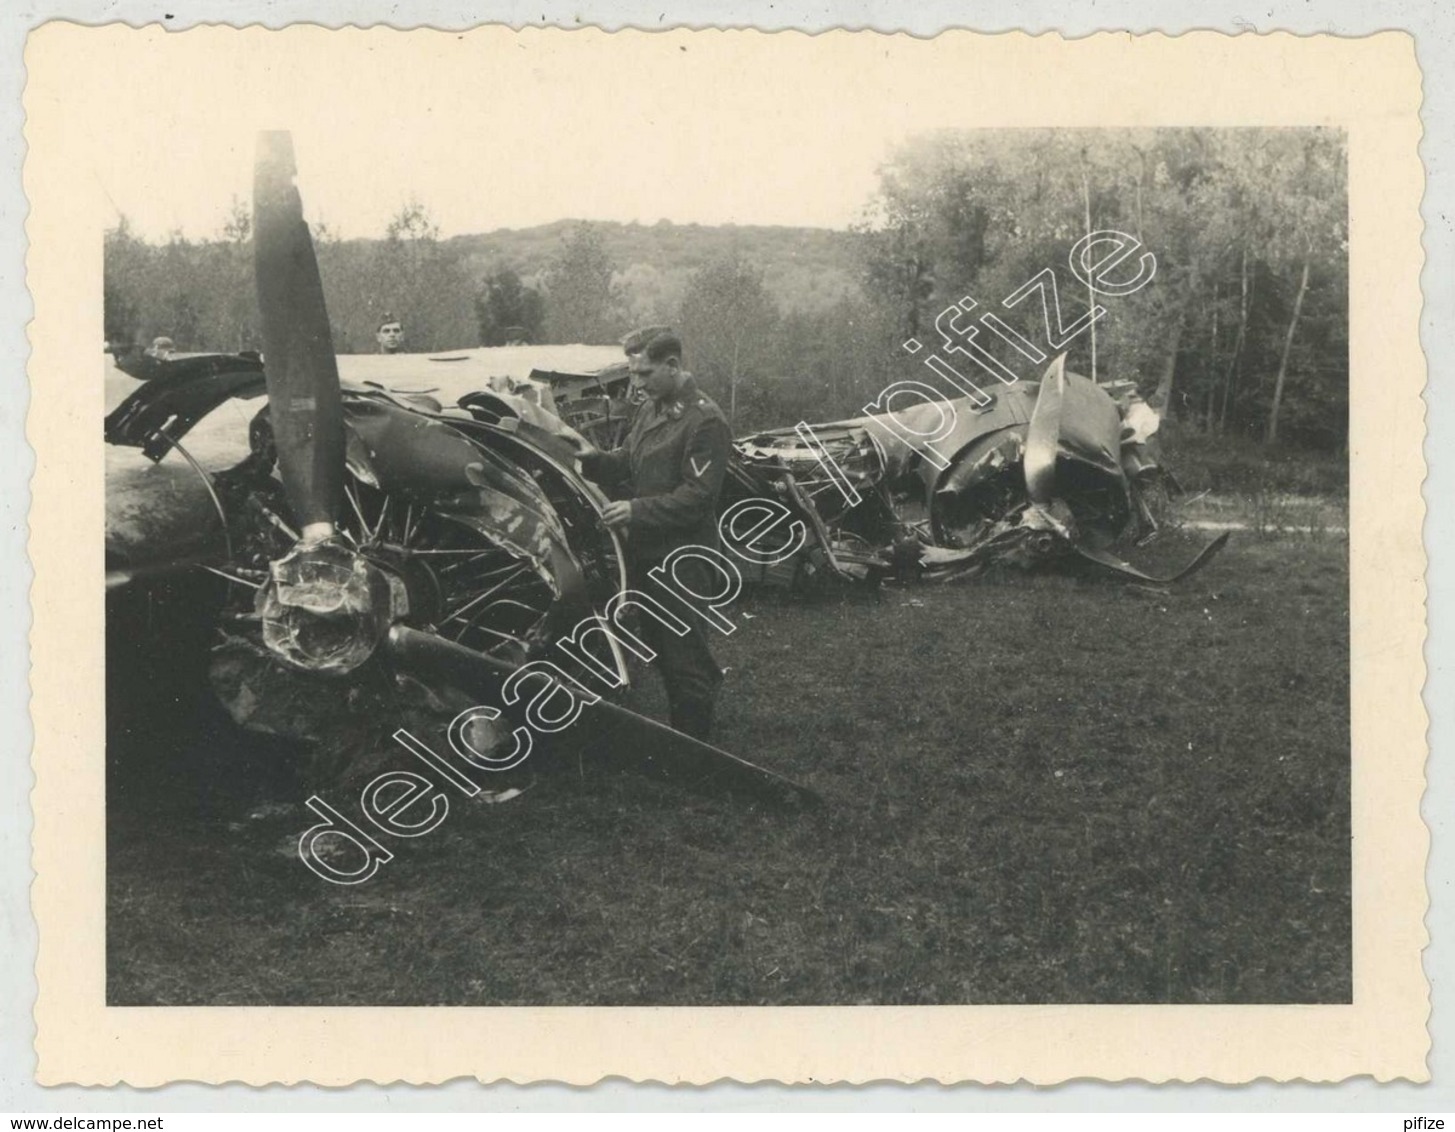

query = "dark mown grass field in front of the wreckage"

[{"left": 108, "top": 523, "right": 1352, "bottom": 1004}]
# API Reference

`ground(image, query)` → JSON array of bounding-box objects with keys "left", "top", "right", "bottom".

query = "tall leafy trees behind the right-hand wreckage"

[{"left": 861, "top": 128, "right": 1349, "bottom": 448}]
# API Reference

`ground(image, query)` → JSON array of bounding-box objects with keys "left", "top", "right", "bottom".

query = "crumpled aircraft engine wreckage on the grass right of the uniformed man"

[{"left": 735, "top": 358, "right": 1225, "bottom": 581}]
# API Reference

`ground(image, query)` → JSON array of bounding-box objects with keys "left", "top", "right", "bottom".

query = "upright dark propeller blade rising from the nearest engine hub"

[{"left": 253, "top": 129, "right": 343, "bottom": 528}]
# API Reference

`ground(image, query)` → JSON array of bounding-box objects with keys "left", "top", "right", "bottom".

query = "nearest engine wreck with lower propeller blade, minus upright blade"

[{"left": 106, "top": 346, "right": 816, "bottom": 808}]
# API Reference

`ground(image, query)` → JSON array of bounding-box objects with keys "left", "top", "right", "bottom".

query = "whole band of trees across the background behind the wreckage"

[{"left": 105, "top": 128, "right": 1349, "bottom": 450}]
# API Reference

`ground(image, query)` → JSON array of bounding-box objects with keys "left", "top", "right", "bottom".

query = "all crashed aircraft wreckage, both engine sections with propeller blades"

[{"left": 105, "top": 134, "right": 1224, "bottom": 802}]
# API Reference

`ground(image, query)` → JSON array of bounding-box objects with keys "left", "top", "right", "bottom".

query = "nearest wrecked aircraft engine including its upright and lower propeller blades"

[{"left": 105, "top": 132, "right": 816, "bottom": 803}]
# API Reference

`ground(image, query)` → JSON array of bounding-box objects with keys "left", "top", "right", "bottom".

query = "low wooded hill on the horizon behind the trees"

[{"left": 447, "top": 220, "right": 861, "bottom": 317}]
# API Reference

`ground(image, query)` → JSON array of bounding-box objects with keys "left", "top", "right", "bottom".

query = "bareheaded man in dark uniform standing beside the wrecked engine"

[{"left": 581, "top": 327, "right": 732, "bottom": 739}]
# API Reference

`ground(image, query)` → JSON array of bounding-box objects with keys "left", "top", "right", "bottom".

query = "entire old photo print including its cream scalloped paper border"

[{"left": 26, "top": 26, "right": 1427, "bottom": 1084}]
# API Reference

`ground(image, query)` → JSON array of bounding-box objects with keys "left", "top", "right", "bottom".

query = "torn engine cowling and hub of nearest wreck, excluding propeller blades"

[{"left": 106, "top": 355, "right": 626, "bottom": 738}]
